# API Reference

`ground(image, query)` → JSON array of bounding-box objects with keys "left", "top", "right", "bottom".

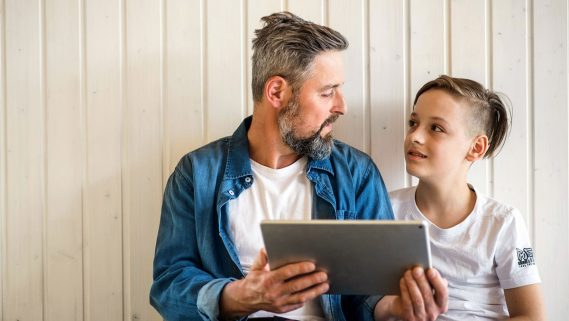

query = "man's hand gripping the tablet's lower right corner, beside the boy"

[{"left": 374, "top": 267, "right": 448, "bottom": 321}]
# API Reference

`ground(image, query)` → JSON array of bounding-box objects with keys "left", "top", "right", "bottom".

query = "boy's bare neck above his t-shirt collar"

[{"left": 415, "top": 180, "right": 476, "bottom": 228}]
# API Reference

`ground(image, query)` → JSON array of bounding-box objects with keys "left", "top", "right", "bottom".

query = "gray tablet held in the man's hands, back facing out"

[{"left": 261, "top": 220, "right": 431, "bottom": 295}]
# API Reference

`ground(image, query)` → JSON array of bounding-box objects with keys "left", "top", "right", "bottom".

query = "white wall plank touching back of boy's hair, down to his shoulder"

[{"left": 491, "top": 0, "right": 533, "bottom": 221}]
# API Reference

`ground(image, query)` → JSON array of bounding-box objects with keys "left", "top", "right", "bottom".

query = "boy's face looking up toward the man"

[{"left": 404, "top": 89, "right": 473, "bottom": 182}]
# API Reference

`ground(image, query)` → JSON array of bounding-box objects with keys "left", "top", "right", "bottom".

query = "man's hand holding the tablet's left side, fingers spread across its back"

[{"left": 220, "top": 249, "right": 329, "bottom": 319}]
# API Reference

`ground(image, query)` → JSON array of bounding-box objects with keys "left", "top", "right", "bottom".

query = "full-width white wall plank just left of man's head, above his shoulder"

[{"left": 205, "top": 0, "right": 248, "bottom": 141}]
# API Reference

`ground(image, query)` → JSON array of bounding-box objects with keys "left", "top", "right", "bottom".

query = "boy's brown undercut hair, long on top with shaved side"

[{"left": 413, "top": 75, "right": 511, "bottom": 158}]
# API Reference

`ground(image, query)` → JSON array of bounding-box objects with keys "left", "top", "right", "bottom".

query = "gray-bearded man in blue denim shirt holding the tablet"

[{"left": 150, "top": 13, "right": 447, "bottom": 321}]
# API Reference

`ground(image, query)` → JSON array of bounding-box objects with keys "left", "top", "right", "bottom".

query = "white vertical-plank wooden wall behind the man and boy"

[{"left": 0, "top": 0, "right": 569, "bottom": 321}]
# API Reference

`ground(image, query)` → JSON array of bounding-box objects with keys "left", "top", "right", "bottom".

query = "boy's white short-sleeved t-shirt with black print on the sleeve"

[{"left": 389, "top": 186, "right": 540, "bottom": 321}]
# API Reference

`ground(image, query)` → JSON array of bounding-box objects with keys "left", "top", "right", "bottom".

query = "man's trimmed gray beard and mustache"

[{"left": 278, "top": 97, "right": 338, "bottom": 159}]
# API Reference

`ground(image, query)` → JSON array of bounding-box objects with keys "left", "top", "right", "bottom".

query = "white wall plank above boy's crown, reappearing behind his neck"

[{"left": 450, "top": 0, "right": 491, "bottom": 194}]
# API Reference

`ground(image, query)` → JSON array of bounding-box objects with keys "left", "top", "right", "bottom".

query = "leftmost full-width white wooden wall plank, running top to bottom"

[{"left": 4, "top": 0, "right": 45, "bottom": 320}]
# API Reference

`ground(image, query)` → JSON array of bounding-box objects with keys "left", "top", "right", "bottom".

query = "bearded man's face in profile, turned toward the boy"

[{"left": 278, "top": 52, "right": 347, "bottom": 159}]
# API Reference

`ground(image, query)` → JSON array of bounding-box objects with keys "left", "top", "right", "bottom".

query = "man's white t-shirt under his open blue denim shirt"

[{"left": 228, "top": 158, "right": 325, "bottom": 321}]
